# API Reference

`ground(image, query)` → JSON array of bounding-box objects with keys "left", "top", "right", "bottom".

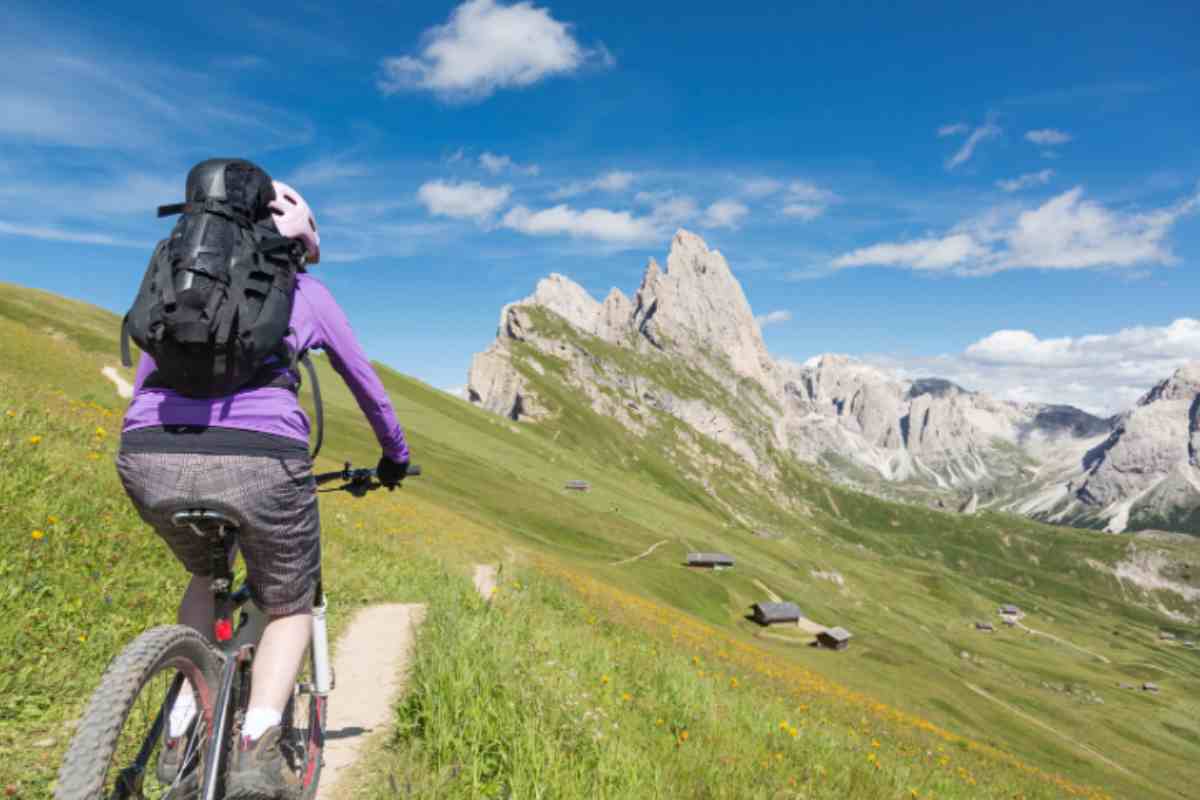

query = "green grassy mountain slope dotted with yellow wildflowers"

[{"left": 0, "top": 284, "right": 1200, "bottom": 798}]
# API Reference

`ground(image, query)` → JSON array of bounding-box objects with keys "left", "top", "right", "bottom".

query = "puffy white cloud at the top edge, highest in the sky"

[{"left": 379, "top": 0, "right": 612, "bottom": 101}]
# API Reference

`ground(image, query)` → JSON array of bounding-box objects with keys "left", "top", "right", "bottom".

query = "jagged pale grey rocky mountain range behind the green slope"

[{"left": 468, "top": 230, "right": 1200, "bottom": 530}]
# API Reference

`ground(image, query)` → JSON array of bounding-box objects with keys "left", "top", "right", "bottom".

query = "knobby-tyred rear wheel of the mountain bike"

[{"left": 54, "top": 625, "right": 220, "bottom": 800}]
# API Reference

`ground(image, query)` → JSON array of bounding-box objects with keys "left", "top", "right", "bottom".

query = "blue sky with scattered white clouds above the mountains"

[{"left": 0, "top": 0, "right": 1200, "bottom": 410}]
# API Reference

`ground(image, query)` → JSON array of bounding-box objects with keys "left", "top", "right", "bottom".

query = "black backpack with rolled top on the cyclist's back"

[{"left": 121, "top": 158, "right": 324, "bottom": 456}]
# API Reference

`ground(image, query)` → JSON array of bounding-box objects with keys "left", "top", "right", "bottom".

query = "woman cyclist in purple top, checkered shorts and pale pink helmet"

[{"left": 116, "top": 181, "right": 408, "bottom": 800}]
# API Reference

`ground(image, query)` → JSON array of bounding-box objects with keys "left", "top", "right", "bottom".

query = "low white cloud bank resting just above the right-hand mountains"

[{"left": 868, "top": 318, "right": 1200, "bottom": 415}]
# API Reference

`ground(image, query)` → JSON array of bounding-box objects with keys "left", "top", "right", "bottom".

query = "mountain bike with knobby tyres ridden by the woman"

[{"left": 54, "top": 463, "right": 421, "bottom": 800}]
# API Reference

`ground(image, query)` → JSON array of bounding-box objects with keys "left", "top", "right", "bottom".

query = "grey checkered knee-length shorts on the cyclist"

[{"left": 116, "top": 451, "right": 320, "bottom": 616}]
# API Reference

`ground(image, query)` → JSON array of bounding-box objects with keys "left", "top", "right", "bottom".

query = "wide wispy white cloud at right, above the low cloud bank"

[{"left": 832, "top": 187, "right": 1200, "bottom": 275}]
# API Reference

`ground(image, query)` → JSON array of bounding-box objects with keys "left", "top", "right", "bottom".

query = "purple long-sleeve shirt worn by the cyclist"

[{"left": 124, "top": 273, "right": 408, "bottom": 462}]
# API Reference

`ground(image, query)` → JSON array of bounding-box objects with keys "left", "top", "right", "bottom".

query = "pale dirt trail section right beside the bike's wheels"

[{"left": 317, "top": 603, "right": 425, "bottom": 800}]
